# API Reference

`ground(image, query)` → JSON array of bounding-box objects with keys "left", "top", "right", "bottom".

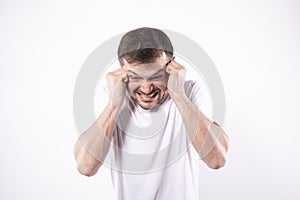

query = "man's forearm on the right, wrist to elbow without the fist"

[{"left": 171, "top": 95, "right": 228, "bottom": 169}]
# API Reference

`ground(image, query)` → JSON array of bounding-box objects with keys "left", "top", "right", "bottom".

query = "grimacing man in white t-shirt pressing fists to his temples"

[{"left": 74, "top": 28, "right": 228, "bottom": 200}]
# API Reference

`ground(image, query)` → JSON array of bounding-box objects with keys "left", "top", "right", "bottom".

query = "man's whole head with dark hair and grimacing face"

[{"left": 118, "top": 28, "right": 173, "bottom": 109}]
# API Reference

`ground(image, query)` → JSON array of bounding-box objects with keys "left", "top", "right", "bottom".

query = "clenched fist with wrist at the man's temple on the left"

[{"left": 106, "top": 67, "right": 128, "bottom": 108}]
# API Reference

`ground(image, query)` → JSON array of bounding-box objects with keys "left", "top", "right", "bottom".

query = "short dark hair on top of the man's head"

[{"left": 118, "top": 27, "right": 173, "bottom": 65}]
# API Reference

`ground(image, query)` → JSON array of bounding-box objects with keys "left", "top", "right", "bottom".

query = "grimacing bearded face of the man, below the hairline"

[{"left": 127, "top": 59, "right": 168, "bottom": 109}]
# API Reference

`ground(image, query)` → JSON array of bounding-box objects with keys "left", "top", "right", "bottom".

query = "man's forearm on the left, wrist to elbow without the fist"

[{"left": 74, "top": 104, "right": 118, "bottom": 176}]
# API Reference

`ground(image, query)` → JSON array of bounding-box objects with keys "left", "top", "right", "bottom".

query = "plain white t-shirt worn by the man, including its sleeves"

[{"left": 98, "top": 81, "right": 212, "bottom": 200}]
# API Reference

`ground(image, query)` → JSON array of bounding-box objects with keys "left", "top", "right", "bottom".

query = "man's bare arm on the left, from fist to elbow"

[{"left": 74, "top": 68, "right": 126, "bottom": 176}]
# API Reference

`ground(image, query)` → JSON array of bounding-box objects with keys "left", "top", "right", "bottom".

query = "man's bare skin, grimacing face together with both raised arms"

[{"left": 74, "top": 54, "right": 229, "bottom": 176}]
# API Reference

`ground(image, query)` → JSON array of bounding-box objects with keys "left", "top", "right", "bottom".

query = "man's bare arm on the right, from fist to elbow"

[{"left": 167, "top": 60, "right": 229, "bottom": 169}]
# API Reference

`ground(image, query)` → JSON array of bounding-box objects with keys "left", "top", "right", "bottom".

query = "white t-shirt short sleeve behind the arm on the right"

[{"left": 185, "top": 80, "right": 213, "bottom": 120}]
